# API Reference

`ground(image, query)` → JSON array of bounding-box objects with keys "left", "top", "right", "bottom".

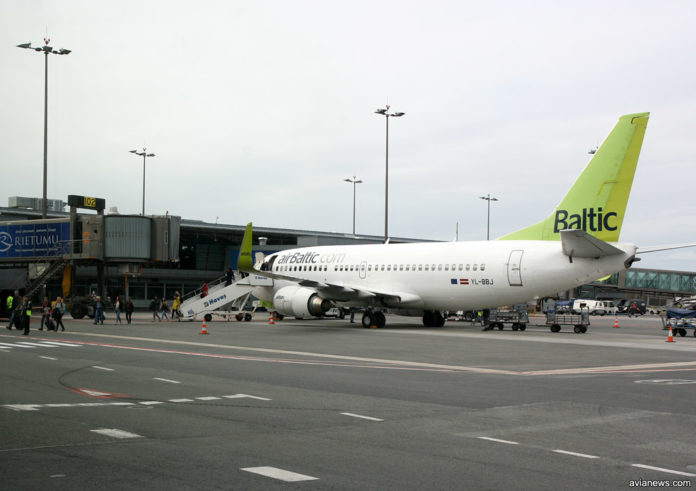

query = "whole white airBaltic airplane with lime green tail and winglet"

[{"left": 238, "top": 113, "right": 683, "bottom": 328}]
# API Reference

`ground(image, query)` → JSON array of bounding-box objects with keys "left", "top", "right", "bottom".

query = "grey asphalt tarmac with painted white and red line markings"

[{"left": 0, "top": 313, "right": 696, "bottom": 490}]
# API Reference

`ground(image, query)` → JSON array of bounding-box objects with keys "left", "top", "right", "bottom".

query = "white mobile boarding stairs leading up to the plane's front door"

[{"left": 179, "top": 272, "right": 255, "bottom": 321}]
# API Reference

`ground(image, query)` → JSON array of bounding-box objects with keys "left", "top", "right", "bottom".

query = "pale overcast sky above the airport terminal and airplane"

[{"left": 0, "top": 0, "right": 696, "bottom": 271}]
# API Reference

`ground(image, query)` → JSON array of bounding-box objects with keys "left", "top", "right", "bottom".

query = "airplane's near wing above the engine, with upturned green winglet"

[{"left": 237, "top": 223, "right": 422, "bottom": 306}]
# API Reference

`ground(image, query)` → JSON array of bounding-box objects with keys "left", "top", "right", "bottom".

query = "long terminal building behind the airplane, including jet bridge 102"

[{"left": 0, "top": 196, "right": 696, "bottom": 309}]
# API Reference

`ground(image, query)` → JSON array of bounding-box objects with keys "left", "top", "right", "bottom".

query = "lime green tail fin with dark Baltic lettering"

[{"left": 500, "top": 113, "right": 650, "bottom": 242}]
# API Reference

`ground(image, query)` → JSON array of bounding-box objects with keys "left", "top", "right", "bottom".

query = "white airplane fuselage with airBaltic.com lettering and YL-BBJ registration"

[{"left": 254, "top": 240, "right": 636, "bottom": 310}]
